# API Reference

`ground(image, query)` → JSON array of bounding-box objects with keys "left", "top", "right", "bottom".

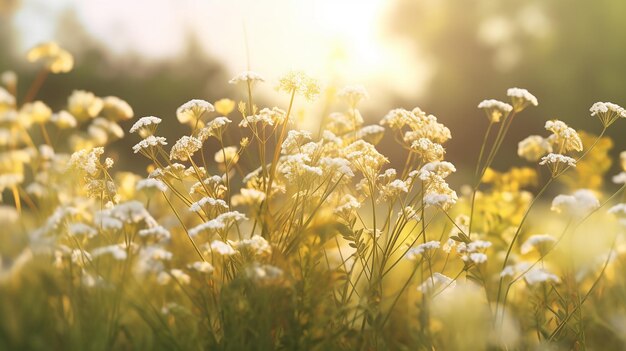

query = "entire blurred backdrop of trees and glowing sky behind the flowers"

[{"left": 0, "top": 0, "right": 626, "bottom": 182}]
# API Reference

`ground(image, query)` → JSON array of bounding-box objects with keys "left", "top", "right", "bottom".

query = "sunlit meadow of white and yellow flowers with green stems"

[{"left": 0, "top": 43, "right": 626, "bottom": 350}]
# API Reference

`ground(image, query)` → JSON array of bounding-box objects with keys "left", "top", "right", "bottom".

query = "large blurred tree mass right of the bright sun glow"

[{"left": 389, "top": 0, "right": 626, "bottom": 176}]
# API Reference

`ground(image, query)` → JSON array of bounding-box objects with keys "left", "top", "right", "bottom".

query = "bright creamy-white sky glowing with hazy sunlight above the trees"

[{"left": 16, "top": 0, "right": 429, "bottom": 102}]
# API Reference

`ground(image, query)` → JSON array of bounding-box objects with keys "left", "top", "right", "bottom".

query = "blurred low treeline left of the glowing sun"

[{"left": 0, "top": 9, "right": 231, "bottom": 171}]
